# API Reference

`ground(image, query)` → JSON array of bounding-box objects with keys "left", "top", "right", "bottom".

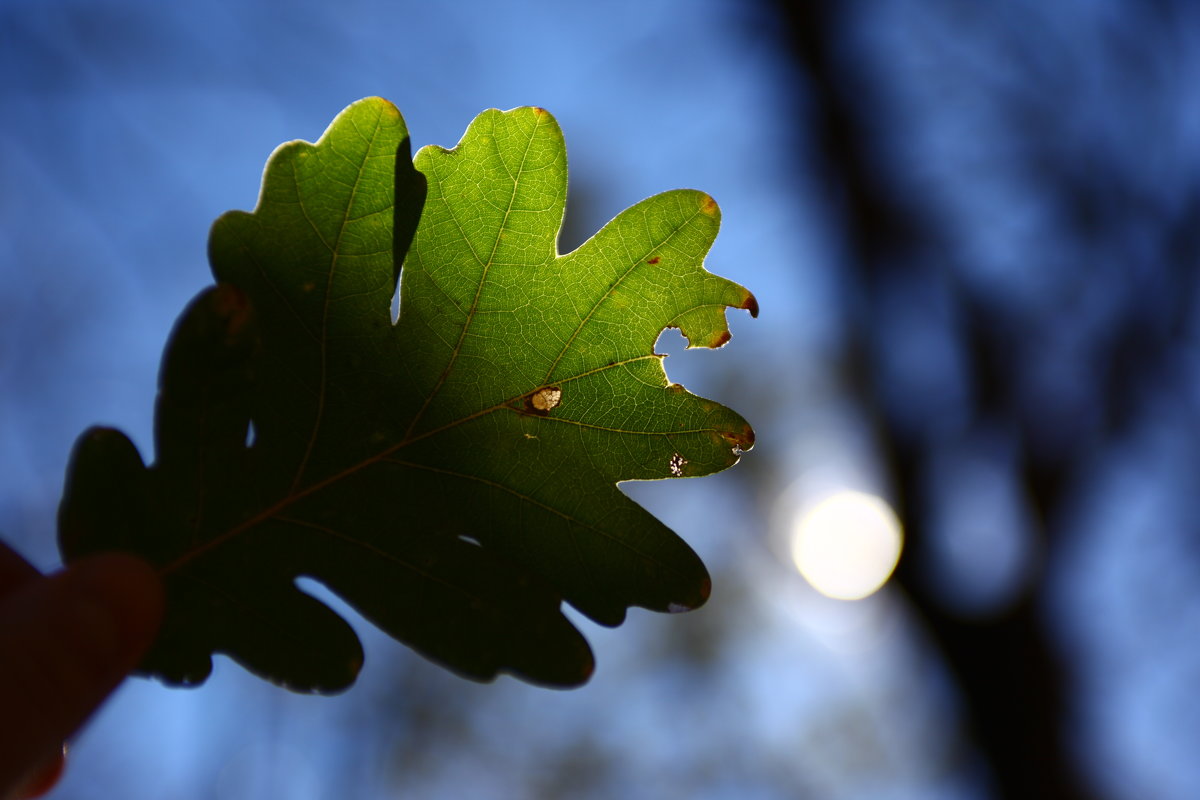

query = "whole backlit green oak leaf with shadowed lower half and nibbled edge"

[{"left": 59, "top": 98, "right": 756, "bottom": 692}]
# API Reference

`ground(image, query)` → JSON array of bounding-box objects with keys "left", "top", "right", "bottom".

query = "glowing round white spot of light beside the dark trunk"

[{"left": 792, "top": 491, "right": 902, "bottom": 600}]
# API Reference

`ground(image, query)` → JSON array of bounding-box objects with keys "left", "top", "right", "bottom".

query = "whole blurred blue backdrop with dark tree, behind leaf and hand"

[{"left": 0, "top": 0, "right": 1200, "bottom": 800}]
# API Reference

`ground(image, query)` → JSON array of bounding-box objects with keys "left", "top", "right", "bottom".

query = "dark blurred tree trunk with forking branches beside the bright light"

[{"left": 763, "top": 0, "right": 1128, "bottom": 800}]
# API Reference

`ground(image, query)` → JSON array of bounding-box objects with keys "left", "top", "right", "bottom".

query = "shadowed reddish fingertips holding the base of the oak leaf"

[{"left": 0, "top": 542, "right": 163, "bottom": 800}]
